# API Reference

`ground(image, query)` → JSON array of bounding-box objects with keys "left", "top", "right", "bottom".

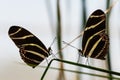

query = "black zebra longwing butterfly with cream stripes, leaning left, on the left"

[{"left": 8, "top": 26, "right": 51, "bottom": 68}]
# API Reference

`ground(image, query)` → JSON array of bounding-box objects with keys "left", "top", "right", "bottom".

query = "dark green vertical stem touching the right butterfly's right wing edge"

[{"left": 106, "top": 0, "right": 112, "bottom": 80}]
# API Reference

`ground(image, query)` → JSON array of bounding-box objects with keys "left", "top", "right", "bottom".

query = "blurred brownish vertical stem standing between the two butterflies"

[{"left": 57, "top": 0, "right": 65, "bottom": 80}]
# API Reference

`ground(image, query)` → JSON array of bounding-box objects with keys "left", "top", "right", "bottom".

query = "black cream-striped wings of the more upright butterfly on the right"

[{"left": 82, "top": 9, "right": 109, "bottom": 60}]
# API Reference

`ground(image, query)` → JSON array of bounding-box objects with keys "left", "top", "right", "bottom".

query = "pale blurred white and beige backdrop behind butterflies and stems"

[{"left": 0, "top": 0, "right": 120, "bottom": 80}]
